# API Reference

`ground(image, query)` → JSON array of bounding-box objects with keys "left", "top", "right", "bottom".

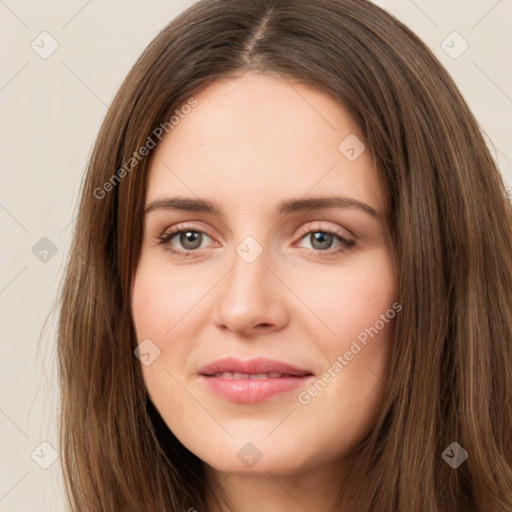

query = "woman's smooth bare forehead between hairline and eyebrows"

[{"left": 146, "top": 72, "right": 383, "bottom": 214}]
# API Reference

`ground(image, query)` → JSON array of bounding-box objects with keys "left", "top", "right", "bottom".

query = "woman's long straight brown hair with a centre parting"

[{"left": 58, "top": 0, "right": 512, "bottom": 512}]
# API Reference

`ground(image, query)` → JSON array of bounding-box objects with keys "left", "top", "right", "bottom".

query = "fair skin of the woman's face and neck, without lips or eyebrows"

[{"left": 132, "top": 72, "right": 397, "bottom": 512}]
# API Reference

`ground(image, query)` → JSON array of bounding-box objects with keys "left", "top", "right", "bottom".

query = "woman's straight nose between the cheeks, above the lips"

[{"left": 213, "top": 246, "right": 289, "bottom": 337}]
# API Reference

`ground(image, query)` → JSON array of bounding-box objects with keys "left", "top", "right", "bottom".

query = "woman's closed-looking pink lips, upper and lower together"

[{"left": 199, "top": 357, "right": 313, "bottom": 403}]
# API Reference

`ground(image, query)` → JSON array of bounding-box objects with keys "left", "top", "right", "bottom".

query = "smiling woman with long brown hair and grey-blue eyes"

[{"left": 59, "top": 0, "right": 512, "bottom": 512}]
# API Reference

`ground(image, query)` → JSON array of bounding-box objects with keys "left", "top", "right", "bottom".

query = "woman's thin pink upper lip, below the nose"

[{"left": 199, "top": 357, "right": 313, "bottom": 377}]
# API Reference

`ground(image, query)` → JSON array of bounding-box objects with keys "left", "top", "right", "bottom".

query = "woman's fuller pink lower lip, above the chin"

[{"left": 202, "top": 375, "right": 312, "bottom": 404}]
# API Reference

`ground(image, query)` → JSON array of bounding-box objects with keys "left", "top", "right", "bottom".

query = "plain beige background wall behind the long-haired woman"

[{"left": 0, "top": 0, "right": 512, "bottom": 512}]
